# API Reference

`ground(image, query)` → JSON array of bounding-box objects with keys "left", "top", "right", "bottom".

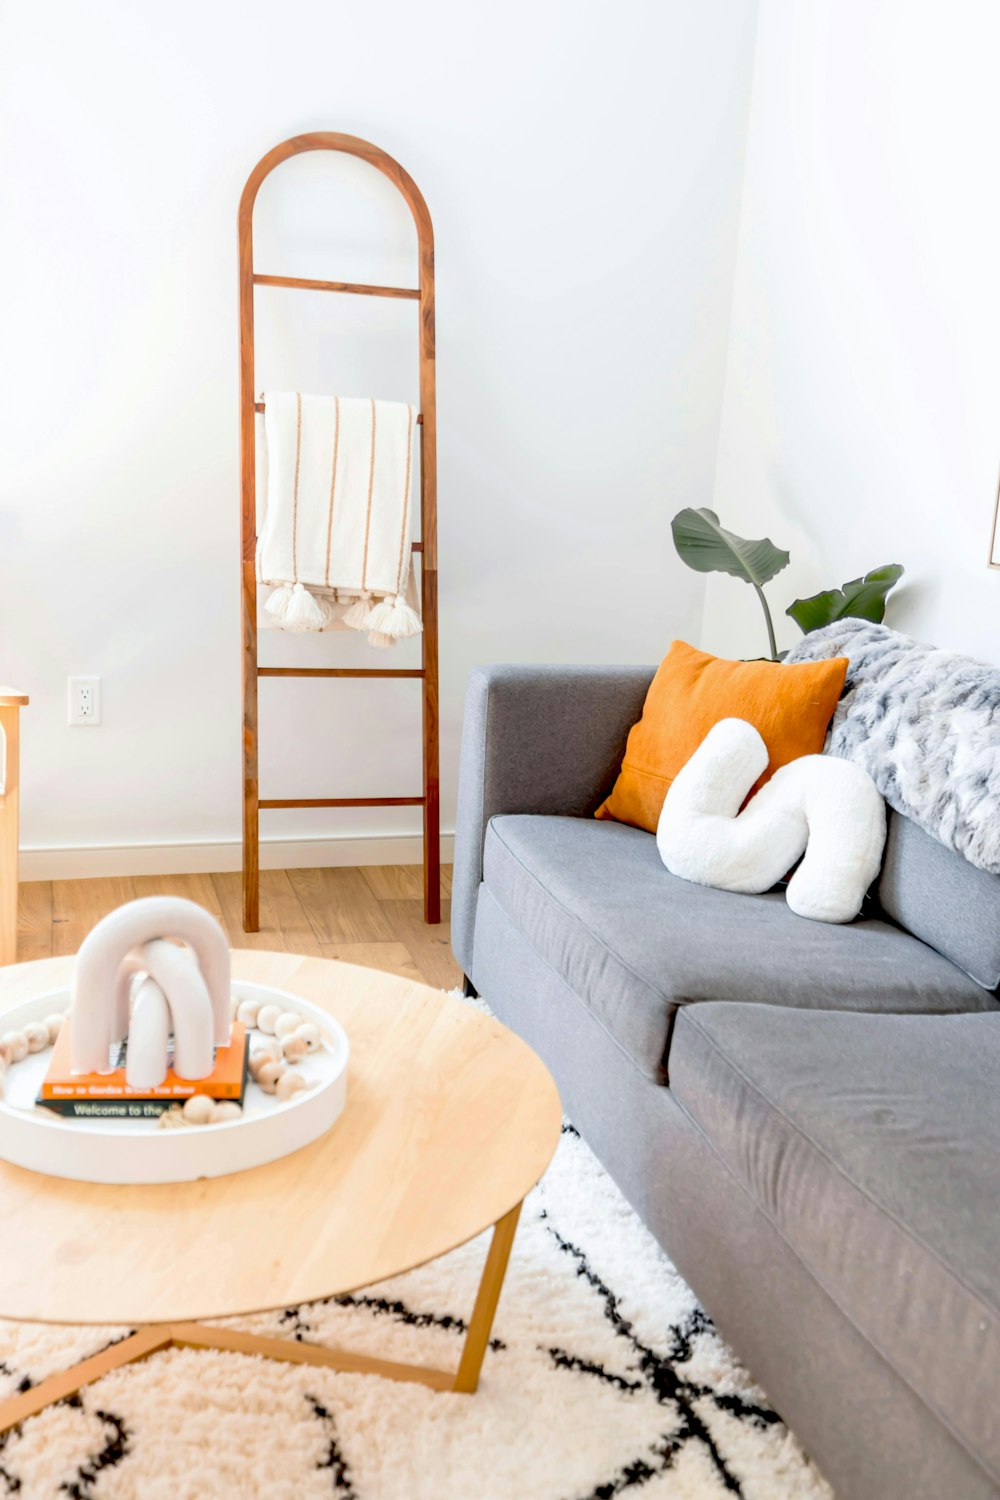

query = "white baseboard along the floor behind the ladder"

[{"left": 18, "top": 834, "right": 454, "bottom": 881}]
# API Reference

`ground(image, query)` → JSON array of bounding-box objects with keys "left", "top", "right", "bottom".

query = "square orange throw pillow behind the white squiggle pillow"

[{"left": 594, "top": 641, "right": 847, "bottom": 834}]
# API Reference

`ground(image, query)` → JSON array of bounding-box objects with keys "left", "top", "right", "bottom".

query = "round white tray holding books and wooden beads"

[{"left": 0, "top": 980, "right": 351, "bottom": 1184}]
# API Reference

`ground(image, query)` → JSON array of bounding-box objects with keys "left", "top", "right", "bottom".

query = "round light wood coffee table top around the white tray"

[{"left": 0, "top": 951, "right": 561, "bottom": 1325}]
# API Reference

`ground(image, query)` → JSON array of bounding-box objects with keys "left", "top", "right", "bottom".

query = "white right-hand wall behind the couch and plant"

[{"left": 703, "top": 0, "right": 1000, "bottom": 662}]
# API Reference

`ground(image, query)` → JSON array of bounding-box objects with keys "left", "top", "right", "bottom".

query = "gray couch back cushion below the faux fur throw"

[{"left": 879, "top": 813, "right": 1000, "bottom": 990}]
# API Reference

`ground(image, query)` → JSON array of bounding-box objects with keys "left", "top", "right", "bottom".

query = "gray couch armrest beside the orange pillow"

[{"left": 451, "top": 666, "right": 654, "bottom": 974}]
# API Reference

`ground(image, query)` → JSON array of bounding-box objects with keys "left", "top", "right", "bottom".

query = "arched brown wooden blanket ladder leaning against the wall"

[{"left": 240, "top": 141, "right": 441, "bottom": 932}]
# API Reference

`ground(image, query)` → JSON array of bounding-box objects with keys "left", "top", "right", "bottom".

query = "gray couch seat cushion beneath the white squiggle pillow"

[{"left": 483, "top": 815, "right": 997, "bottom": 1079}]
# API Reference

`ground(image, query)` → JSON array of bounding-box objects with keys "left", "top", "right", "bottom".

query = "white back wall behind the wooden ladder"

[{"left": 0, "top": 0, "right": 758, "bottom": 875}]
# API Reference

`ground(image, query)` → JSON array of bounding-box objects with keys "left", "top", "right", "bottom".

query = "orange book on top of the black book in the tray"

[{"left": 37, "top": 1017, "right": 247, "bottom": 1116}]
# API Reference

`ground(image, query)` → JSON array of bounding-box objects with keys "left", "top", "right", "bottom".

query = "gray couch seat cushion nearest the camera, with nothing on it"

[{"left": 670, "top": 1005, "right": 1000, "bottom": 1479}]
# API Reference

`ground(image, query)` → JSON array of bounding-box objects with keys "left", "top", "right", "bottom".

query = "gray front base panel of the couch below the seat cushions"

[{"left": 472, "top": 890, "right": 1000, "bottom": 1500}]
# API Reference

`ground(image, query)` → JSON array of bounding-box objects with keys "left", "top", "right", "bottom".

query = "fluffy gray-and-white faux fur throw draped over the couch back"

[{"left": 786, "top": 620, "right": 1000, "bottom": 875}]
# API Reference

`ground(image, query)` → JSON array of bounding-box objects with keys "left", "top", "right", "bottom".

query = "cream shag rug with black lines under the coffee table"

[{"left": 0, "top": 1008, "right": 832, "bottom": 1500}]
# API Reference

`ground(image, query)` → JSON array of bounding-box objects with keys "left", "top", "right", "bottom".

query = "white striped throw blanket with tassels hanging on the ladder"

[{"left": 256, "top": 392, "right": 423, "bottom": 647}]
